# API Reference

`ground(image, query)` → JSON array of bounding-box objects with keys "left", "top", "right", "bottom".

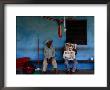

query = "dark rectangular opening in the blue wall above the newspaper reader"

[{"left": 66, "top": 20, "right": 87, "bottom": 45}]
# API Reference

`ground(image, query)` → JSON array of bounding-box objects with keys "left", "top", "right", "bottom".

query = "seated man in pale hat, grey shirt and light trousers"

[{"left": 43, "top": 40, "right": 57, "bottom": 73}]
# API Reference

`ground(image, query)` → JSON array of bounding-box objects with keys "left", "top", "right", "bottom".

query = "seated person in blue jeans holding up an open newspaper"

[{"left": 63, "top": 43, "right": 77, "bottom": 72}]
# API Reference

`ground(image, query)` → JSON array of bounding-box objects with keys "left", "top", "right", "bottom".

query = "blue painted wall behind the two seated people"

[{"left": 16, "top": 16, "right": 94, "bottom": 60}]
